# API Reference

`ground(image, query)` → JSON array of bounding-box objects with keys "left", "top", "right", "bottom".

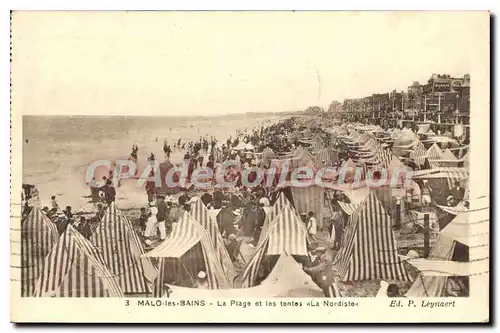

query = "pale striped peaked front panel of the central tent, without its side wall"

[{"left": 267, "top": 206, "right": 307, "bottom": 256}]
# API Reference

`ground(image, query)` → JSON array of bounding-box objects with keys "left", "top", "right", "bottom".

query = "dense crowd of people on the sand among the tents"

[{"left": 23, "top": 111, "right": 465, "bottom": 297}]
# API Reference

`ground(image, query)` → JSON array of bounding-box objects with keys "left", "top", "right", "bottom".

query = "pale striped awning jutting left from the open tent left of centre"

[{"left": 144, "top": 212, "right": 201, "bottom": 258}]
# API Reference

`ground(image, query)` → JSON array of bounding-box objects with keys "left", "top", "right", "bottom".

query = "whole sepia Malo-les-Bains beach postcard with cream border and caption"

[{"left": 10, "top": 11, "right": 490, "bottom": 323}]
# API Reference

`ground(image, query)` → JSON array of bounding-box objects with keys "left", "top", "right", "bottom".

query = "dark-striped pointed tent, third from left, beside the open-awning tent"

[{"left": 90, "top": 203, "right": 157, "bottom": 294}]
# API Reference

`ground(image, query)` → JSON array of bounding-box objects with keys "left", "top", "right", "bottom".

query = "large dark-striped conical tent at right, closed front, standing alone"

[{"left": 335, "top": 192, "right": 410, "bottom": 281}]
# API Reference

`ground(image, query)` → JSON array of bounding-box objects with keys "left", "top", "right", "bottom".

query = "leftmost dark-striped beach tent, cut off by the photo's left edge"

[{"left": 21, "top": 206, "right": 59, "bottom": 297}]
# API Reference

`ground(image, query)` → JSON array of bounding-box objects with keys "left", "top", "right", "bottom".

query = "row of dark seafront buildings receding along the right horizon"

[{"left": 330, "top": 74, "right": 470, "bottom": 124}]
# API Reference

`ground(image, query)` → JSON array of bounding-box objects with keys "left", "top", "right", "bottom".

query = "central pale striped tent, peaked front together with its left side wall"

[{"left": 242, "top": 205, "right": 308, "bottom": 288}]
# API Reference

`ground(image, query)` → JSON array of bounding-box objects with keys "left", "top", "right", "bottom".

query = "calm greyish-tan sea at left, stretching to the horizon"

[{"left": 23, "top": 113, "right": 287, "bottom": 211}]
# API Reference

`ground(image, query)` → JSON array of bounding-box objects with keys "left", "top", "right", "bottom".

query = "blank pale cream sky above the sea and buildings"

[{"left": 11, "top": 11, "right": 489, "bottom": 116}]
